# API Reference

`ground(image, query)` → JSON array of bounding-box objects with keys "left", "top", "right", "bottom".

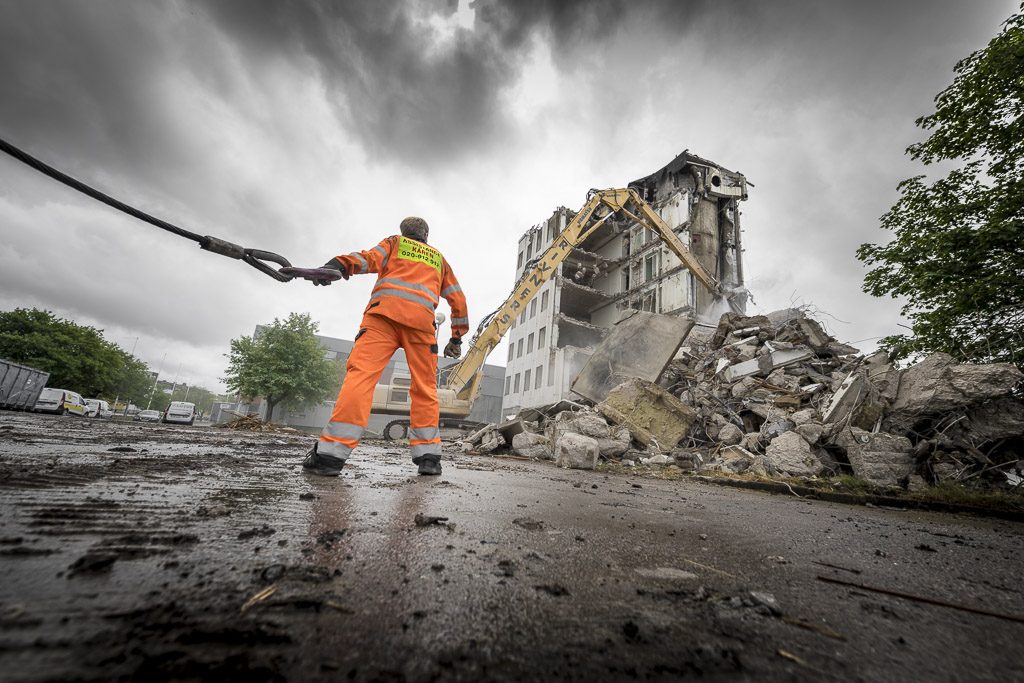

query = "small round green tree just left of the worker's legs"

[{"left": 224, "top": 313, "right": 336, "bottom": 421}]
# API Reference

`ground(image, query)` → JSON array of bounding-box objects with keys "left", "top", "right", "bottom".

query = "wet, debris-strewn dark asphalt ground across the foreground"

[{"left": 0, "top": 413, "right": 1024, "bottom": 681}]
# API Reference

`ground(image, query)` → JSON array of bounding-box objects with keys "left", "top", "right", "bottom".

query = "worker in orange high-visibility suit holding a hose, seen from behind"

[{"left": 302, "top": 217, "right": 469, "bottom": 476}]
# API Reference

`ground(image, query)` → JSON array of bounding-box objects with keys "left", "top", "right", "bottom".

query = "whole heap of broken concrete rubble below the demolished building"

[{"left": 471, "top": 309, "right": 1024, "bottom": 488}]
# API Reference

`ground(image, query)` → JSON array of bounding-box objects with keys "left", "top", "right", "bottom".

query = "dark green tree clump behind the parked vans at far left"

[{"left": 0, "top": 308, "right": 146, "bottom": 396}]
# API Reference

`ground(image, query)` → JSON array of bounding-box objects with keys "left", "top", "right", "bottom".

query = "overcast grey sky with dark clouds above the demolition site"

[{"left": 0, "top": 0, "right": 1017, "bottom": 390}]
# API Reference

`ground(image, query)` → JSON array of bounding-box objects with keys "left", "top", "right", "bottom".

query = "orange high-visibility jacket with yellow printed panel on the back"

[{"left": 335, "top": 234, "right": 469, "bottom": 339}]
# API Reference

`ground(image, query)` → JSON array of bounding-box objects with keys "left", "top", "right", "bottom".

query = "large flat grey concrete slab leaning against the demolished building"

[{"left": 570, "top": 311, "right": 693, "bottom": 403}]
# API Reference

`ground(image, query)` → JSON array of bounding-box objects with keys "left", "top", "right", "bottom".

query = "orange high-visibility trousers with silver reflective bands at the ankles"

[{"left": 316, "top": 313, "right": 441, "bottom": 460}]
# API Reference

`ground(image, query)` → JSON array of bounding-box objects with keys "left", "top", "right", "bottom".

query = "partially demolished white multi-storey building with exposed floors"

[{"left": 502, "top": 152, "right": 746, "bottom": 415}]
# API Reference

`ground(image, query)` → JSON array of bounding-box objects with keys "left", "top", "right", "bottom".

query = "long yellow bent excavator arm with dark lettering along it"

[{"left": 446, "top": 187, "right": 719, "bottom": 403}]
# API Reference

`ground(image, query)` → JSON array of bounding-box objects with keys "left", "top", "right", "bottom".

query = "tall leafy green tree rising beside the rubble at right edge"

[{"left": 857, "top": 4, "right": 1024, "bottom": 368}]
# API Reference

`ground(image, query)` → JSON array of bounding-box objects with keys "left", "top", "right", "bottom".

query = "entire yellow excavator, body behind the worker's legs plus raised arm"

[{"left": 373, "top": 187, "right": 721, "bottom": 438}]
